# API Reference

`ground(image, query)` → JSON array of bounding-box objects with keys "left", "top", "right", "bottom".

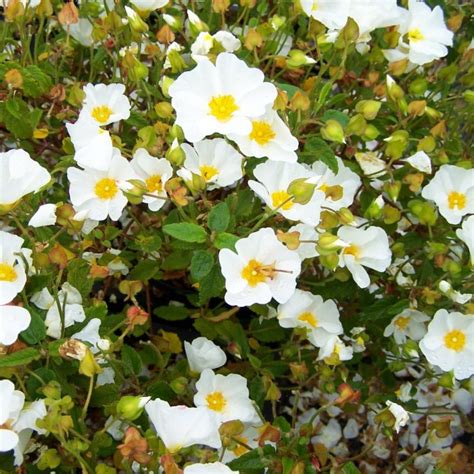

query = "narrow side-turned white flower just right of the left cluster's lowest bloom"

[{"left": 130, "top": 148, "right": 173, "bottom": 211}]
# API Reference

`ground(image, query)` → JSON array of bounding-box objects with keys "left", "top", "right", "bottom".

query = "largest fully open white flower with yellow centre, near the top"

[{"left": 169, "top": 53, "right": 277, "bottom": 142}]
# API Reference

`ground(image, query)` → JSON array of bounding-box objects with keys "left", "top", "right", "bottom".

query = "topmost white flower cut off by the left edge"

[{"left": 0, "top": 149, "right": 51, "bottom": 206}]
